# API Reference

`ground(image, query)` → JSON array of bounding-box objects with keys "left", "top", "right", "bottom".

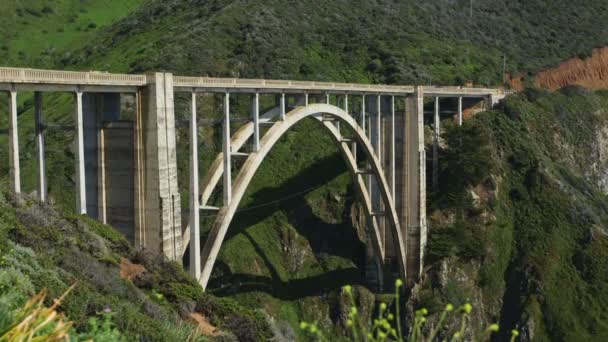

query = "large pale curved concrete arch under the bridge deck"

[{"left": 200, "top": 104, "right": 406, "bottom": 289}]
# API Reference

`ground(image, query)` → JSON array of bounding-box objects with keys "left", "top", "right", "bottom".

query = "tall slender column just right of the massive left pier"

[{"left": 189, "top": 91, "right": 201, "bottom": 279}]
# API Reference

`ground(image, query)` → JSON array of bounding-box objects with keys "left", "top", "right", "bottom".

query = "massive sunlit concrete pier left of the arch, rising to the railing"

[{"left": 135, "top": 73, "right": 182, "bottom": 260}]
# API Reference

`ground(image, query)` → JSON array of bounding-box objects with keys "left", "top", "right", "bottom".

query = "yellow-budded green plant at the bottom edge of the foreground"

[{"left": 300, "top": 279, "right": 519, "bottom": 342}]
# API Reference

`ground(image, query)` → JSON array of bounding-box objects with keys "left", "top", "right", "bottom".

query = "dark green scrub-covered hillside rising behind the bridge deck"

[{"left": 54, "top": 0, "right": 608, "bottom": 85}]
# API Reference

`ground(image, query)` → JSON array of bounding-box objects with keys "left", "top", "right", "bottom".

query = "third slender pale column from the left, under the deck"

[{"left": 74, "top": 91, "right": 87, "bottom": 214}]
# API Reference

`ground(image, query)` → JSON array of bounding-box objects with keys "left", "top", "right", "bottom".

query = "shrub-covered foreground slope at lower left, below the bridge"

[{"left": 0, "top": 184, "right": 272, "bottom": 341}]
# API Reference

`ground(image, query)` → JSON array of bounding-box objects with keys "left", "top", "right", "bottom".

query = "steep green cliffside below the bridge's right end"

[{"left": 419, "top": 89, "right": 608, "bottom": 341}]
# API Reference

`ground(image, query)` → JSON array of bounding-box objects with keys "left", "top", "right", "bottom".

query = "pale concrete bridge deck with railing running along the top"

[{"left": 0, "top": 67, "right": 505, "bottom": 97}]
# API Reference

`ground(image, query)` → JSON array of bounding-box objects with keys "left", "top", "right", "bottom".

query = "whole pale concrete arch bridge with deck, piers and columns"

[{"left": 0, "top": 68, "right": 505, "bottom": 288}]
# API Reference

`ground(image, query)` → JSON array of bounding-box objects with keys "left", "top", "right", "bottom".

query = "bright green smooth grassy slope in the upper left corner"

[{"left": 0, "top": 0, "right": 144, "bottom": 67}]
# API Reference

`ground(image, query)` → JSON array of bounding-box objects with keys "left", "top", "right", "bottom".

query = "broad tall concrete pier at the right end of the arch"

[{"left": 401, "top": 86, "right": 427, "bottom": 285}]
